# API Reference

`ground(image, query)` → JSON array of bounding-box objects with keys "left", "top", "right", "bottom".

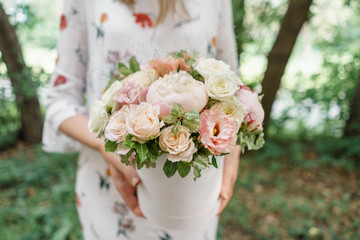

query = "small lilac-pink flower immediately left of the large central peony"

[{"left": 114, "top": 81, "right": 142, "bottom": 105}]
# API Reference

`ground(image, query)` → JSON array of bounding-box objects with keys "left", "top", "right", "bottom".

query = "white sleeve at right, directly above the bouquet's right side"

[{"left": 216, "top": 0, "right": 238, "bottom": 73}]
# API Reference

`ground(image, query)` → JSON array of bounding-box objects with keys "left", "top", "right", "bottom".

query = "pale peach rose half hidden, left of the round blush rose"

[{"left": 105, "top": 105, "right": 130, "bottom": 143}]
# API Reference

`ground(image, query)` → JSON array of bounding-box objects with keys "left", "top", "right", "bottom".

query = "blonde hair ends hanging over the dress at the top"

[{"left": 119, "top": 0, "right": 189, "bottom": 25}]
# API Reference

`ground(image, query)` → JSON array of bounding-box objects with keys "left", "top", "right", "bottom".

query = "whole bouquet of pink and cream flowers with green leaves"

[{"left": 88, "top": 51, "right": 264, "bottom": 179}]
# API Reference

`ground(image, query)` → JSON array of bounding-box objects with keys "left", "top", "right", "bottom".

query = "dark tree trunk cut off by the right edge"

[{"left": 344, "top": 71, "right": 360, "bottom": 137}]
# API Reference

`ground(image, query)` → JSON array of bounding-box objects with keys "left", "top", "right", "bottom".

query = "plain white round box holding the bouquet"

[{"left": 137, "top": 155, "right": 224, "bottom": 230}]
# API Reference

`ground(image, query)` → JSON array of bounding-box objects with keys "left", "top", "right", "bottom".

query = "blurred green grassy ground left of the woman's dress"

[{"left": 0, "top": 146, "right": 81, "bottom": 240}]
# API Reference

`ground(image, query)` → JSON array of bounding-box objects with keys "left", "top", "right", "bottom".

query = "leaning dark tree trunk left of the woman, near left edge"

[{"left": 0, "top": 4, "right": 42, "bottom": 143}]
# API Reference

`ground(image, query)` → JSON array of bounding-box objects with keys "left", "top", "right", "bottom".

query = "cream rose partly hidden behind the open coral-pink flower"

[{"left": 211, "top": 97, "right": 247, "bottom": 129}]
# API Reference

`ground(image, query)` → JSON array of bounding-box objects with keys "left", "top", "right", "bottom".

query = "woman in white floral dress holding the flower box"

[{"left": 43, "top": 0, "right": 239, "bottom": 240}]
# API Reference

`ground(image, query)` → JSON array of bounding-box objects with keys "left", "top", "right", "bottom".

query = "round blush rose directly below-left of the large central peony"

[{"left": 126, "top": 102, "right": 164, "bottom": 143}]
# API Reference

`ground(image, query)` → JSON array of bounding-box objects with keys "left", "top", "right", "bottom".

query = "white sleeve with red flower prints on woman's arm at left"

[{"left": 43, "top": 0, "right": 87, "bottom": 152}]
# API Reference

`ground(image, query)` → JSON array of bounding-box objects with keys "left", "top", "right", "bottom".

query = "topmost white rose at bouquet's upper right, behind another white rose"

[{"left": 195, "top": 58, "right": 232, "bottom": 79}]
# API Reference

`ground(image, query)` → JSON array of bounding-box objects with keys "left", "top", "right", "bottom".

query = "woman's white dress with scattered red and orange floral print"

[{"left": 43, "top": 0, "right": 237, "bottom": 239}]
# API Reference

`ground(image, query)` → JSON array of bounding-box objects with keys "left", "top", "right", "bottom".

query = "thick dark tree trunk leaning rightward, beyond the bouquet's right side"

[{"left": 262, "top": 0, "right": 312, "bottom": 128}]
